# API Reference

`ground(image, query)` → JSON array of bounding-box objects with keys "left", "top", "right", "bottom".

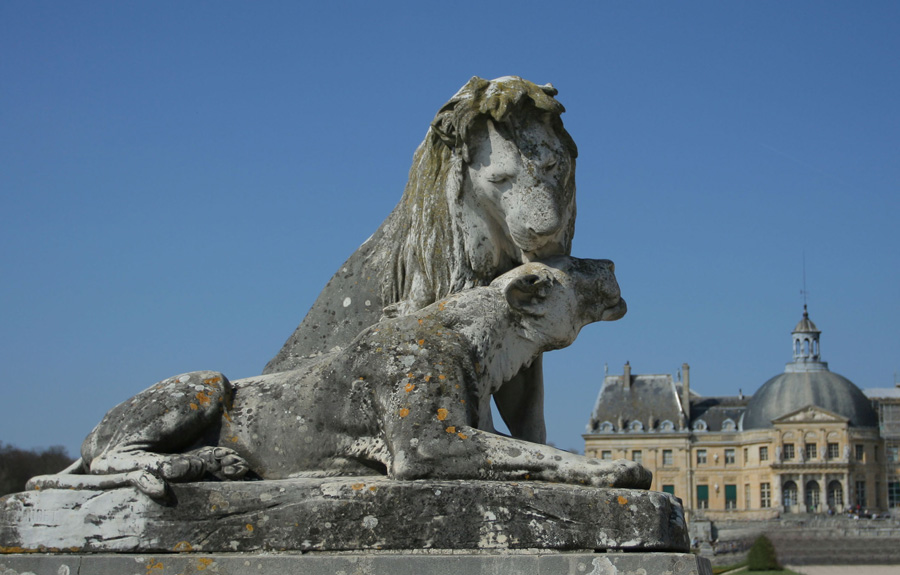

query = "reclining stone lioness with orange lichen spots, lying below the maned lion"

[{"left": 32, "top": 256, "right": 650, "bottom": 497}]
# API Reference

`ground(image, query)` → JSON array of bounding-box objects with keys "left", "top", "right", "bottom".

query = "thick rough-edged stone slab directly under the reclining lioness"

[{"left": 0, "top": 477, "right": 688, "bottom": 553}]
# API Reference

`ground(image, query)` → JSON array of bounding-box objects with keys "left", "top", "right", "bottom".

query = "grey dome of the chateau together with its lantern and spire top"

[{"left": 743, "top": 305, "right": 878, "bottom": 429}]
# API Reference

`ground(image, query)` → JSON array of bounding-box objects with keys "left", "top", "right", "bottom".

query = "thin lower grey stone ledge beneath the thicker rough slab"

[{"left": 0, "top": 551, "right": 712, "bottom": 575}]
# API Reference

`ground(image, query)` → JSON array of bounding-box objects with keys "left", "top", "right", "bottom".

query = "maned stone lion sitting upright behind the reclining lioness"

[{"left": 263, "top": 76, "right": 577, "bottom": 443}]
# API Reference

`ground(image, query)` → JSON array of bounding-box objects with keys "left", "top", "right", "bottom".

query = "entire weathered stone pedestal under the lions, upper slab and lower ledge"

[{"left": 0, "top": 482, "right": 710, "bottom": 575}]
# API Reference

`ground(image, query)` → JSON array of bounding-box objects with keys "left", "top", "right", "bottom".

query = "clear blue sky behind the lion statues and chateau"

[{"left": 0, "top": 1, "right": 900, "bottom": 454}]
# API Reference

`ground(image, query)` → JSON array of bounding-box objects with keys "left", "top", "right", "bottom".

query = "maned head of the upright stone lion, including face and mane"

[{"left": 382, "top": 76, "right": 578, "bottom": 313}]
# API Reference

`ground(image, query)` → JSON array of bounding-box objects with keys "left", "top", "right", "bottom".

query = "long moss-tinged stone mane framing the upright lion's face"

[{"left": 382, "top": 76, "right": 578, "bottom": 312}]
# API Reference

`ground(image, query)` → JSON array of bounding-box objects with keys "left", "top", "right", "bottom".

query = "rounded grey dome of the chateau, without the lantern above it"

[{"left": 743, "top": 369, "right": 878, "bottom": 429}]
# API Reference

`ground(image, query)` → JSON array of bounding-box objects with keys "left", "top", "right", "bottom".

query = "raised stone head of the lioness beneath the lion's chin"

[{"left": 491, "top": 256, "right": 627, "bottom": 351}]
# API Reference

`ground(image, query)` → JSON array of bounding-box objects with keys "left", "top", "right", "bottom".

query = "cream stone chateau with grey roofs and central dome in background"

[{"left": 583, "top": 306, "right": 900, "bottom": 519}]
